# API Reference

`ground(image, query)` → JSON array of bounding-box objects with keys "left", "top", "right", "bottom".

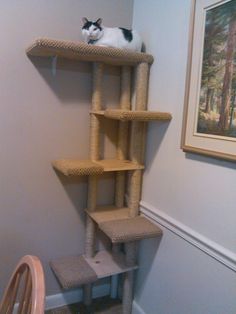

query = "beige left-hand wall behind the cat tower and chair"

[{"left": 0, "top": 0, "right": 133, "bottom": 295}]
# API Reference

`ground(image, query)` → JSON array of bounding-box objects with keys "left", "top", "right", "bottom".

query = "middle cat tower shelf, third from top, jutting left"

[{"left": 52, "top": 159, "right": 144, "bottom": 176}]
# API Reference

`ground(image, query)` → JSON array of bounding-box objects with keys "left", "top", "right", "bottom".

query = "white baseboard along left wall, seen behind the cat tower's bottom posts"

[{"left": 45, "top": 284, "right": 110, "bottom": 310}]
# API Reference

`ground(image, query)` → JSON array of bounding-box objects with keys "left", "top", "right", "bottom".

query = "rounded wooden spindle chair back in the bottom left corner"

[{"left": 0, "top": 255, "right": 45, "bottom": 314}]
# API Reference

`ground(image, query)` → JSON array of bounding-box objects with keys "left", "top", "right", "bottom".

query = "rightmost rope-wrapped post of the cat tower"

[{"left": 122, "top": 63, "right": 149, "bottom": 314}]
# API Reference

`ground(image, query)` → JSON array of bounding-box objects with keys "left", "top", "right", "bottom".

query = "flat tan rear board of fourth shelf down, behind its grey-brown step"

[{"left": 86, "top": 205, "right": 130, "bottom": 224}]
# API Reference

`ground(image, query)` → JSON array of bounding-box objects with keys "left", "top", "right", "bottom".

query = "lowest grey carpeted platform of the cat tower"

[{"left": 50, "top": 251, "right": 138, "bottom": 289}]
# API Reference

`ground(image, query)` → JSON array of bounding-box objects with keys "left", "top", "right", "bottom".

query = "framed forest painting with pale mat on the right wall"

[{"left": 181, "top": 0, "right": 236, "bottom": 161}]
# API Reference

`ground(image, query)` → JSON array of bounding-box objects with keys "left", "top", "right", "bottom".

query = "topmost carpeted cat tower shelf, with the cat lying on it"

[{"left": 26, "top": 38, "right": 153, "bottom": 66}]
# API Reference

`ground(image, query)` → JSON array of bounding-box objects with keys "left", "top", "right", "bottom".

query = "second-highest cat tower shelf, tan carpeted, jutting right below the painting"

[{"left": 91, "top": 109, "right": 172, "bottom": 122}]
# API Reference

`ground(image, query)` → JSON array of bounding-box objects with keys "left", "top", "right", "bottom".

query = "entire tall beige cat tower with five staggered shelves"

[{"left": 26, "top": 38, "right": 171, "bottom": 314}]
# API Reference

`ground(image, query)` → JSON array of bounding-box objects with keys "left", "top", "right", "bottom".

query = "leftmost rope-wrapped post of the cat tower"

[{"left": 84, "top": 63, "right": 104, "bottom": 306}]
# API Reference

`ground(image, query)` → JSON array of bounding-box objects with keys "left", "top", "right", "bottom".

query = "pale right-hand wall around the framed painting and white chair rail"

[{"left": 133, "top": 0, "right": 236, "bottom": 314}]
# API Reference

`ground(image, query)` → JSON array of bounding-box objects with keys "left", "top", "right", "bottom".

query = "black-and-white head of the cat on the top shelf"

[{"left": 82, "top": 17, "right": 103, "bottom": 43}]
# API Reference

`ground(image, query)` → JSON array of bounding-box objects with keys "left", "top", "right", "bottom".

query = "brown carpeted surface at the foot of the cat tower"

[{"left": 45, "top": 297, "right": 122, "bottom": 314}]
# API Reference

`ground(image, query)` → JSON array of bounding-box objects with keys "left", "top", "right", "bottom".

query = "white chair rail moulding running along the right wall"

[{"left": 140, "top": 201, "right": 236, "bottom": 271}]
